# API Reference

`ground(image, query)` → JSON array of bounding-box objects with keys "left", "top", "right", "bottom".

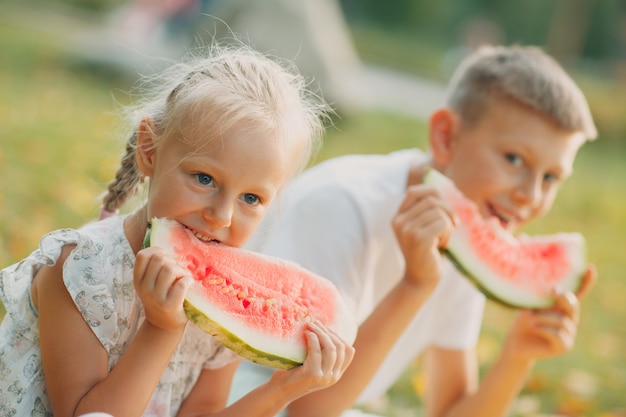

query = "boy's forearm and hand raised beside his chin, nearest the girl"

[{"left": 288, "top": 185, "right": 454, "bottom": 417}]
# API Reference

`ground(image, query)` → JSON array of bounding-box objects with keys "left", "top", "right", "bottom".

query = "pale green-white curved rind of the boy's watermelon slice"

[{"left": 423, "top": 168, "right": 587, "bottom": 309}]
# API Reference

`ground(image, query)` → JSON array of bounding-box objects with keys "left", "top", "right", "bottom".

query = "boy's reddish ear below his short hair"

[{"left": 428, "top": 107, "right": 459, "bottom": 165}]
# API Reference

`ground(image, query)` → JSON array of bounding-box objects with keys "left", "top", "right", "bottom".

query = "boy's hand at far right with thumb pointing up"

[{"left": 505, "top": 266, "right": 597, "bottom": 361}]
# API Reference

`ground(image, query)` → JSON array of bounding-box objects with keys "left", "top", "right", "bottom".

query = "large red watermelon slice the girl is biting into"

[{"left": 145, "top": 218, "right": 357, "bottom": 369}]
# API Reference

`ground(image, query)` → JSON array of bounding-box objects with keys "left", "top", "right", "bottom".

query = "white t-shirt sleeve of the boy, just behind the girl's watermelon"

[{"left": 251, "top": 187, "right": 366, "bottom": 311}]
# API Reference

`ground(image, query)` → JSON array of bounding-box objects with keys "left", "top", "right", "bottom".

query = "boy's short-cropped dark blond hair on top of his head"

[{"left": 447, "top": 45, "right": 598, "bottom": 140}]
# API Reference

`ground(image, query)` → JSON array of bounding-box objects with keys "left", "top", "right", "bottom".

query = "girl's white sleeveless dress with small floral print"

[{"left": 0, "top": 216, "right": 237, "bottom": 417}]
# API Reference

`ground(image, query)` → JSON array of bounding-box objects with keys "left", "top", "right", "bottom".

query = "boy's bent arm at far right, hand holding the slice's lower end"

[{"left": 426, "top": 267, "right": 596, "bottom": 417}]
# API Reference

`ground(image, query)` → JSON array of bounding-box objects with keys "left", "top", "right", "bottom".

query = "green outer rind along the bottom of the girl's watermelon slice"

[{"left": 183, "top": 299, "right": 302, "bottom": 369}]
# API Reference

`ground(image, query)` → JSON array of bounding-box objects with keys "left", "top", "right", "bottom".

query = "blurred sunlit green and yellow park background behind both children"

[{"left": 0, "top": 0, "right": 626, "bottom": 417}]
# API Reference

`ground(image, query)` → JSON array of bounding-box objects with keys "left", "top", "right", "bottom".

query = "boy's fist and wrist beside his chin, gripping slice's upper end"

[{"left": 392, "top": 184, "right": 458, "bottom": 289}]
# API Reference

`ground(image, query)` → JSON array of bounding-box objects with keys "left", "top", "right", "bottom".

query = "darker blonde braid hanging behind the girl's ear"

[{"left": 101, "top": 132, "right": 141, "bottom": 217}]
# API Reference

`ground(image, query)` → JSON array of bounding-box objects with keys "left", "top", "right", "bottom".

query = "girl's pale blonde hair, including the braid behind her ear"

[{"left": 101, "top": 42, "right": 330, "bottom": 217}]
